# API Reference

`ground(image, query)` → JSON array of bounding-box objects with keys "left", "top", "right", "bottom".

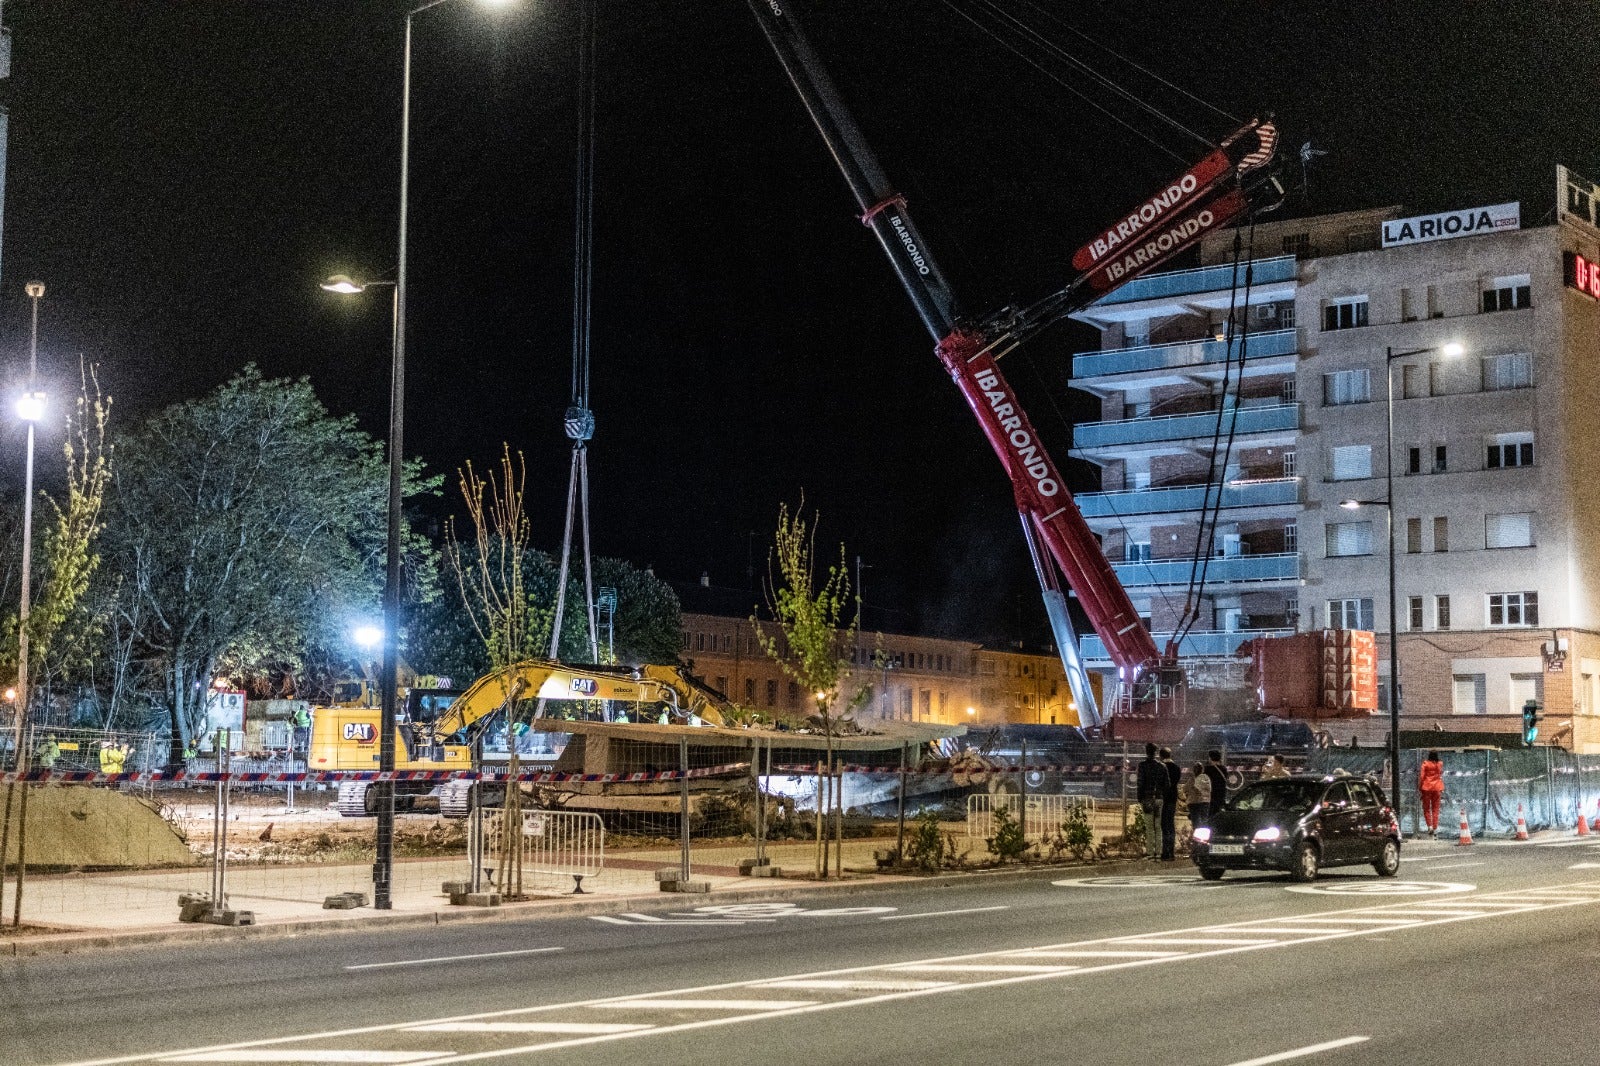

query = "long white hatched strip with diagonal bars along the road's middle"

[{"left": 62, "top": 880, "right": 1600, "bottom": 1066}]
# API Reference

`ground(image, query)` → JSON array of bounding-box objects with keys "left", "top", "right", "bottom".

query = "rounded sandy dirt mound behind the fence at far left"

[{"left": 0, "top": 784, "right": 197, "bottom": 869}]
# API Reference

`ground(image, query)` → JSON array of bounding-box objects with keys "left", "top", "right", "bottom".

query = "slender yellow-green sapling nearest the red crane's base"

[{"left": 750, "top": 499, "right": 872, "bottom": 877}]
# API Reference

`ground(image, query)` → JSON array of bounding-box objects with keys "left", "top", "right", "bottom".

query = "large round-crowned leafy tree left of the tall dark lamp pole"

[{"left": 106, "top": 367, "right": 437, "bottom": 755}]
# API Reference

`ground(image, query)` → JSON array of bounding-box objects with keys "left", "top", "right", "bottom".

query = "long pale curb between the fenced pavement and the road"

[{"left": 0, "top": 860, "right": 1170, "bottom": 959}]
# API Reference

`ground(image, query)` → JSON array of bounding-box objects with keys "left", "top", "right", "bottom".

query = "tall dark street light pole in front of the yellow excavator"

[{"left": 323, "top": 0, "right": 518, "bottom": 911}]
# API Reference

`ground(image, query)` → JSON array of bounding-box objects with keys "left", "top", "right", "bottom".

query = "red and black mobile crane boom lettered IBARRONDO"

[{"left": 749, "top": 0, "right": 1283, "bottom": 725}]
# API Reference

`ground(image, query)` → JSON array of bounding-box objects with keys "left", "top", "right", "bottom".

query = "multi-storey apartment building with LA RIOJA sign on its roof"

[{"left": 1074, "top": 170, "right": 1600, "bottom": 751}]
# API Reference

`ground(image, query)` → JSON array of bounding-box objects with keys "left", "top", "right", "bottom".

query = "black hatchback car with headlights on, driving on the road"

[{"left": 1190, "top": 775, "right": 1400, "bottom": 880}]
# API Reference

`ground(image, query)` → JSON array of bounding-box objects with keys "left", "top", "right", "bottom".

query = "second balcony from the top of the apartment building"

[{"left": 1072, "top": 330, "right": 1299, "bottom": 394}]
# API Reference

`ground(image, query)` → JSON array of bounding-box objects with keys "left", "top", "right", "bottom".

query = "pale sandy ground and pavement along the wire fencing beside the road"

[{"left": 0, "top": 786, "right": 1122, "bottom": 954}]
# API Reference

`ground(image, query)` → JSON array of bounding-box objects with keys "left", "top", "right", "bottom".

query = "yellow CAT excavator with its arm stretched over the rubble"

[{"left": 306, "top": 659, "right": 726, "bottom": 818}]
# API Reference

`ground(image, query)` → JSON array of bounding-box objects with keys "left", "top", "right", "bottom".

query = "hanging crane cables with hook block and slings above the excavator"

[{"left": 541, "top": 0, "right": 600, "bottom": 665}]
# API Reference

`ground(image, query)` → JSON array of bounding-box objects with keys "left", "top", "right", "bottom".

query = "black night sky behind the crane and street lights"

[{"left": 0, "top": 0, "right": 1600, "bottom": 640}]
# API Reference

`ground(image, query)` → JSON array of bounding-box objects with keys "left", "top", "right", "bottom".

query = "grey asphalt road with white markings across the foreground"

[{"left": 0, "top": 842, "right": 1600, "bottom": 1066}]
